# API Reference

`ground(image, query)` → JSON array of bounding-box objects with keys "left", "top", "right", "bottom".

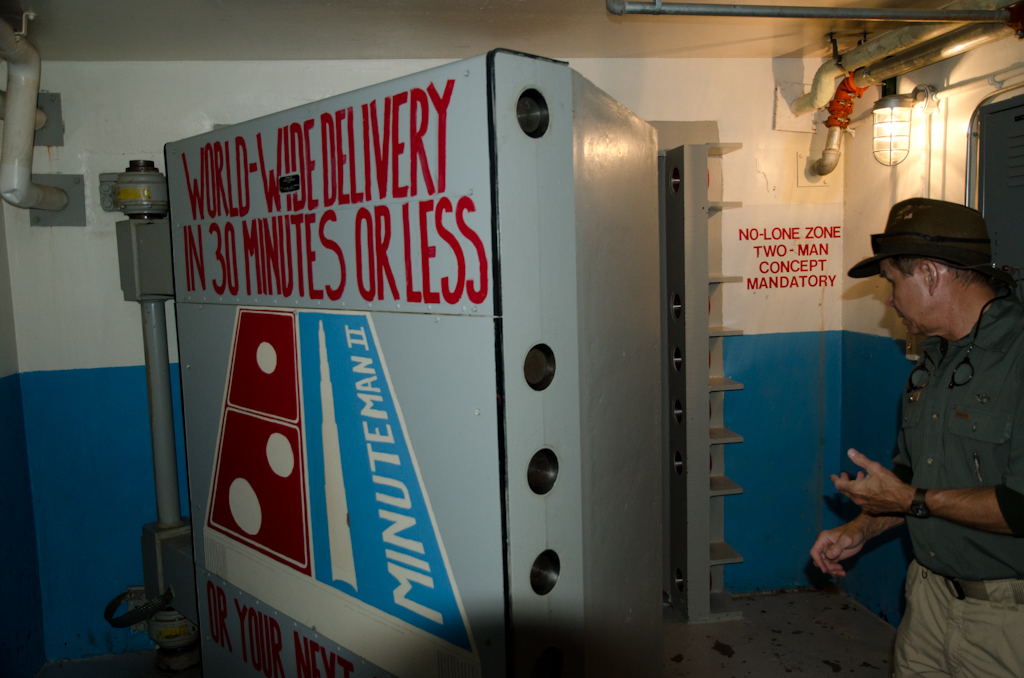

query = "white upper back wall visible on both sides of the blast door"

[{"left": 6, "top": 55, "right": 845, "bottom": 372}]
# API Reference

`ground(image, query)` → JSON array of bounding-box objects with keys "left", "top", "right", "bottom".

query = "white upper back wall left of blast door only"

[{"left": 4, "top": 60, "right": 448, "bottom": 372}]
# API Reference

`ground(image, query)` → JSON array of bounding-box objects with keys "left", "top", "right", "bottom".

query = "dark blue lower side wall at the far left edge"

[{"left": 0, "top": 375, "right": 45, "bottom": 678}]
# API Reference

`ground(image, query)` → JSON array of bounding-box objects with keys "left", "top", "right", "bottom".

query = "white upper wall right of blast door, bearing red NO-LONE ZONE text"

[{"left": 569, "top": 58, "right": 845, "bottom": 334}]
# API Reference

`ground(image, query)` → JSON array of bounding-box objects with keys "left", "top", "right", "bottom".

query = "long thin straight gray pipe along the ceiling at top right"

[{"left": 606, "top": 0, "right": 1010, "bottom": 24}]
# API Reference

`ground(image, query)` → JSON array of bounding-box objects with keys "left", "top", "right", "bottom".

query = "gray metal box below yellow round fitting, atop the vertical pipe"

[{"left": 117, "top": 219, "right": 174, "bottom": 301}]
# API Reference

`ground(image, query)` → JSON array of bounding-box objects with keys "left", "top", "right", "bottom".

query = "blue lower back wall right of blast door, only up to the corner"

[{"left": 723, "top": 332, "right": 843, "bottom": 592}]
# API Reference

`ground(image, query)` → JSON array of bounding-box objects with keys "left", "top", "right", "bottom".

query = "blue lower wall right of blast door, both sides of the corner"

[{"left": 724, "top": 332, "right": 912, "bottom": 625}]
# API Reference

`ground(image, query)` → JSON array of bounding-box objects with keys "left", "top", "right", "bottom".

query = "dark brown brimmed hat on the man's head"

[{"left": 849, "top": 198, "right": 1016, "bottom": 286}]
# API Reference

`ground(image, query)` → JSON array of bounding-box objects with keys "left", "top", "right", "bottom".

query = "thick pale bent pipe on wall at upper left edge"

[{"left": 0, "top": 19, "right": 68, "bottom": 211}]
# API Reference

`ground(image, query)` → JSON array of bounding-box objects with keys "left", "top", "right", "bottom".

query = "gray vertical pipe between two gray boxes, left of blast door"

[{"left": 139, "top": 297, "right": 182, "bottom": 527}]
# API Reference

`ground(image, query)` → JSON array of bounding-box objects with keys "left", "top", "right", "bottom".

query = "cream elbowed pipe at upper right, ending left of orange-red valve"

[{"left": 791, "top": 0, "right": 1006, "bottom": 116}]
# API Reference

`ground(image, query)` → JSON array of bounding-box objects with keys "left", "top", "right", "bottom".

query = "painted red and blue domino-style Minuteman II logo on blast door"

[{"left": 207, "top": 309, "right": 472, "bottom": 650}]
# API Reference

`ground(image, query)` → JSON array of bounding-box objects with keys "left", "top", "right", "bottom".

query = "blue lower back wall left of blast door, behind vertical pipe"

[{"left": 20, "top": 366, "right": 188, "bottom": 661}]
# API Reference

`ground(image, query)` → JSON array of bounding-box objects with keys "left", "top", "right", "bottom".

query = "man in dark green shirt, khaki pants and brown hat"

[{"left": 811, "top": 198, "right": 1024, "bottom": 678}]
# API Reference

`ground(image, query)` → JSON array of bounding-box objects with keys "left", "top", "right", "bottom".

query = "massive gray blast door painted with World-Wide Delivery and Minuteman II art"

[{"left": 166, "top": 51, "right": 662, "bottom": 678}]
